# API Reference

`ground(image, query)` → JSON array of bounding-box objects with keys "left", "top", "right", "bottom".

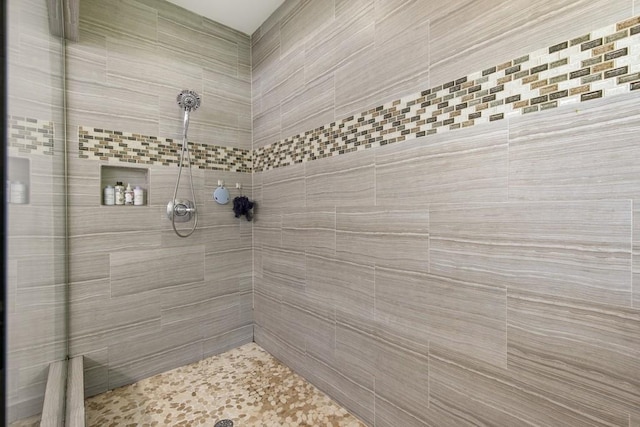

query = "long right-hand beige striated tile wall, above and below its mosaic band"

[{"left": 252, "top": 1, "right": 640, "bottom": 426}]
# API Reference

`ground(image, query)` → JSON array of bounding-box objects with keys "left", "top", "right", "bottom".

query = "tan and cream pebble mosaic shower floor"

[{"left": 85, "top": 343, "right": 364, "bottom": 427}]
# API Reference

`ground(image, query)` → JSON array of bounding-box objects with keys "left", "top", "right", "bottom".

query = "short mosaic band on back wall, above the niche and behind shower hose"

[{"left": 78, "top": 126, "right": 252, "bottom": 173}]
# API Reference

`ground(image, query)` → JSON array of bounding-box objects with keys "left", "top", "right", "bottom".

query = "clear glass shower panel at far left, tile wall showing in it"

[{"left": 5, "top": 0, "right": 67, "bottom": 424}]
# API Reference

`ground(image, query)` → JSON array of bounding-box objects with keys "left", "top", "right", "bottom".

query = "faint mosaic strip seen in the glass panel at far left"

[{"left": 7, "top": 116, "right": 54, "bottom": 156}]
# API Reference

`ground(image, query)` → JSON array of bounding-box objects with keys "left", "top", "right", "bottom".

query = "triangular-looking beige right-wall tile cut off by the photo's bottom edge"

[{"left": 429, "top": 345, "right": 624, "bottom": 426}]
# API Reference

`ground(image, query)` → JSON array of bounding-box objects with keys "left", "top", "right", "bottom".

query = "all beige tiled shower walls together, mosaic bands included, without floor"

[{"left": 8, "top": 0, "right": 640, "bottom": 427}]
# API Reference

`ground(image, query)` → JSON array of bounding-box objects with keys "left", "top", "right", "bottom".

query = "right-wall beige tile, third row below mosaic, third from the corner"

[{"left": 375, "top": 268, "right": 507, "bottom": 367}]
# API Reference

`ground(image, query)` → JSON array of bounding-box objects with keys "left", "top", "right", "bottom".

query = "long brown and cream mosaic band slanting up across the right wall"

[{"left": 254, "top": 16, "right": 640, "bottom": 172}]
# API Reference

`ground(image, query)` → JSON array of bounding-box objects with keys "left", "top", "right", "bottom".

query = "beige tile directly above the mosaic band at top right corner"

[{"left": 429, "top": 0, "right": 637, "bottom": 86}]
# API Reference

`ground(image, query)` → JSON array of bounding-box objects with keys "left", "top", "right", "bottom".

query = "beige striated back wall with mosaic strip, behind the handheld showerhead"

[{"left": 67, "top": 0, "right": 253, "bottom": 402}]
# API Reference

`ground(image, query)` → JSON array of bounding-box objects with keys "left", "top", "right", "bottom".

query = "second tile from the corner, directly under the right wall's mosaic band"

[{"left": 305, "top": 150, "right": 376, "bottom": 208}]
